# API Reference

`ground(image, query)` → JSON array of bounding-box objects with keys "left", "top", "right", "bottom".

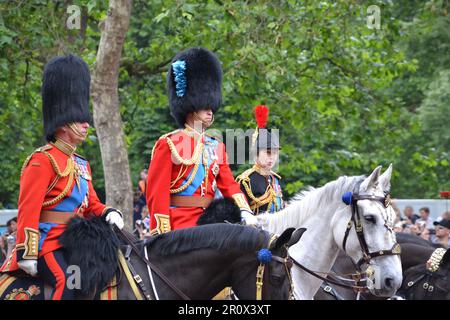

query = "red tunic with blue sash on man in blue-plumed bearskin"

[{"left": 146, "top": 129, "right": 248, "bottom": 233}]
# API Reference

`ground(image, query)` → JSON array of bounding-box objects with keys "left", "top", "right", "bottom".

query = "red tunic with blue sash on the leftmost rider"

[{"left": 0, "top": 143, "right": 107, "bottom": 272}]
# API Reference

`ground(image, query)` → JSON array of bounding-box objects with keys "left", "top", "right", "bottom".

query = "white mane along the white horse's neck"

[{"left": 258, "top": 176, "right": 365, "bottom": 234}]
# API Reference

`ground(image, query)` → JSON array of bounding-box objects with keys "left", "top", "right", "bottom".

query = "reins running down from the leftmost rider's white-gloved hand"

[{"left": 114, "top": 226, "right": 191, "bottom": 300}]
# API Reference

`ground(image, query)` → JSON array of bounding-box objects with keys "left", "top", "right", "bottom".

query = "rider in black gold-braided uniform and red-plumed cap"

[{"left": 236, "top": 105, "right": 284, "bottom": 215}]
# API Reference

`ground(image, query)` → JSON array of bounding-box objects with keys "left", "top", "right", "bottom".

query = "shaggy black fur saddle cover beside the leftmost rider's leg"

[{"left": 59, "top": 217, "right": 120, "bottom": 296}]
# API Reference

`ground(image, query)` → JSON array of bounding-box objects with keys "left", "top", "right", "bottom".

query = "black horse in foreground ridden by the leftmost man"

[{"left": 0, "top": 219, "right": 294, "bottom": 299}]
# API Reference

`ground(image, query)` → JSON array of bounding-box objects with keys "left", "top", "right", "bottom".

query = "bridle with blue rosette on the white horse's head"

[{"left": 342, "top": 184, "right": 401, "bottom": 271}]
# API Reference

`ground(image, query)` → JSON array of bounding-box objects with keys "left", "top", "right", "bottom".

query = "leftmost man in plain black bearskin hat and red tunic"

[{"left": 0, "top": 55, "right": 123, "bottom": 300}]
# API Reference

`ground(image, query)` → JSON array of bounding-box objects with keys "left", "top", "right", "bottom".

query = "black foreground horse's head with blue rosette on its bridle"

[{"left": 232, "top": 228, "right": 305, "bottom": 300}]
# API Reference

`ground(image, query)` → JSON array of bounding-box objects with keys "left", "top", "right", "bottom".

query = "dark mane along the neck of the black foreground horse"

[{"left": 143, "top": 223, "right": 269, "bottom": 256}]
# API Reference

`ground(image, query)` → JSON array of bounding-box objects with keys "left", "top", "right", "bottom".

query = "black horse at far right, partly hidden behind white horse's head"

[{"left": 314, "top": 233, "right": 450, "bottom": 300}]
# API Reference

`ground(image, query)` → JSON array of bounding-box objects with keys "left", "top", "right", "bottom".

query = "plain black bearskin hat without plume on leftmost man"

[{"left": 42, "top": 55, "right": 92, "bottom": 141}]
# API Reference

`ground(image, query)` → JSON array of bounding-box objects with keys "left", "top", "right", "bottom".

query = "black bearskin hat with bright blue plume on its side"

[{"left": 167, "top": 47, "right": 222, "bottom": 128}]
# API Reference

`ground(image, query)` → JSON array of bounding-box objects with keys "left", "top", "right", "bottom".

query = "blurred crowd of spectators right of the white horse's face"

[{"left": 393, "top": 204, "right": 450, "bottom": 248}]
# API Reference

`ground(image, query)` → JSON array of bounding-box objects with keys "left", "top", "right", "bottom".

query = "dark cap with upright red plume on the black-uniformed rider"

[{"left": 253, "top": 105, "right": 280, "bottom": 154}]
